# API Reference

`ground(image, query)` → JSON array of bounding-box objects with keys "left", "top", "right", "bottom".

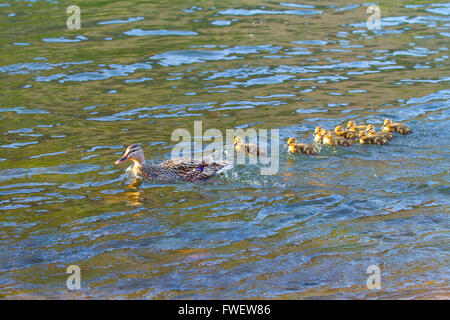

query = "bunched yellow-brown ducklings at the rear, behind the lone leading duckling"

[{"left": 286, "top": 119, "right": 411, "bottom": 155}]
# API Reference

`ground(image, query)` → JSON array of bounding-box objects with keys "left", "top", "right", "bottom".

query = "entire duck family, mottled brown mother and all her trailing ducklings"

[{"left": 116, "top": 119, "right": 411, "bottom": 182}]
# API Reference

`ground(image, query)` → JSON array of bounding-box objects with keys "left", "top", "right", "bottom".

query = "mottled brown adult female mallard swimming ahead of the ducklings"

[{"left": 116, "top": 144, "right": 233, "bottom": 182}]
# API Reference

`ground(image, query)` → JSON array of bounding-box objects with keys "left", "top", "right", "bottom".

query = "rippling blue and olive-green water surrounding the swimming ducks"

[{"left": 0, "top": 0, "right": 450, "bottom": 299}]
